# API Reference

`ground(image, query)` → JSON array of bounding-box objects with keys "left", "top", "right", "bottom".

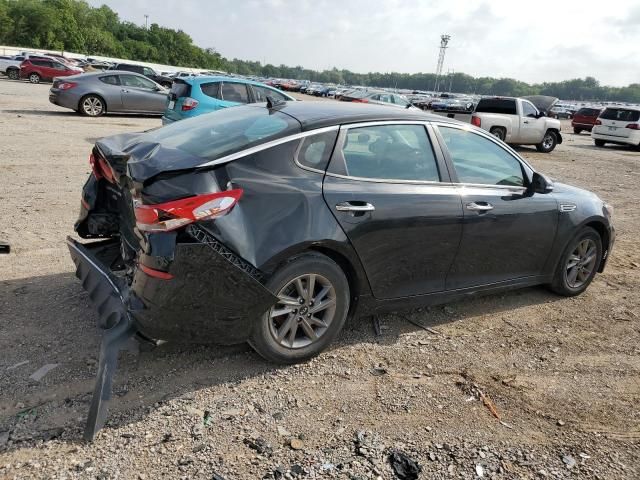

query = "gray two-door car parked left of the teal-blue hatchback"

[{"left": 49, "top": 70, "right": 169, "bottom": 117}]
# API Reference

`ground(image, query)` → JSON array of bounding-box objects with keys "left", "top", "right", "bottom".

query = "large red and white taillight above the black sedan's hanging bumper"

[{"left": 135, "top": 188, "right": 242, "bottom": 232}]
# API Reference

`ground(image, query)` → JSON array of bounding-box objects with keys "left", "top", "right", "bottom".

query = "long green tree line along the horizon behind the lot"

[{"left": 0, "top": 0, "right": 640, "bottom": 103}]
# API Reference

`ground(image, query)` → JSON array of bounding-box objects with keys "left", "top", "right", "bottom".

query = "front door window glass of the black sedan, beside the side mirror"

[{"left": 438, "top": 126, "right": 524, "bottom": 187}]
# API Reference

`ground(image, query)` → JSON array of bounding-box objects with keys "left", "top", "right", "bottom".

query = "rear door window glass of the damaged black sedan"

[{"left": 342, "top": 125, "right": 440, "bottom": 182}]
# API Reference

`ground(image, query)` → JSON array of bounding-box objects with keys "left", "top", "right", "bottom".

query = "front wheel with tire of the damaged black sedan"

[{"left": 549, "top": 227, "right": 602, "bottom": 297}]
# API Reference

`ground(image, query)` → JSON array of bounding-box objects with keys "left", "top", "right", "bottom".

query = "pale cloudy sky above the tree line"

[{"left": 89, "top": 0, "right": 640, "bottom": 86}]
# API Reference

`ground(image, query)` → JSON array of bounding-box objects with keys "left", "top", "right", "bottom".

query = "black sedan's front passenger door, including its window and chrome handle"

[{"left": 438, "top": 124, "right": 559, "bottom": 290}]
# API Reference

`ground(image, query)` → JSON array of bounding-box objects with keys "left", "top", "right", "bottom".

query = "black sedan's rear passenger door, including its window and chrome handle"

[{"left": 323, "top": 122, "right": 463, "bottom": 299}]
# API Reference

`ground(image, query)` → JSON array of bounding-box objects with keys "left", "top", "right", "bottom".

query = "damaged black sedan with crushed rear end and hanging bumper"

[{"left": 69, "top": 102, "right": 615, "bottom": 437}]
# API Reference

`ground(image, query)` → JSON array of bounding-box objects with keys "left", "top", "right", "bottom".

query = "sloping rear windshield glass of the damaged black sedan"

[{"left": 141, "top": 106, "right": 301, "bottom": 160}]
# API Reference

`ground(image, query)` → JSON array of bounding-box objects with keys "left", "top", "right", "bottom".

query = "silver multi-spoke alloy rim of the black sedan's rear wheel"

[{"left": 269, "top": 273, "right": 336, "bottom": 348}]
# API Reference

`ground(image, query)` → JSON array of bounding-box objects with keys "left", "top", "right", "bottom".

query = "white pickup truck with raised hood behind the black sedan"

[{"left": 435, "top": 96, "right": 562, "bottom": 153}]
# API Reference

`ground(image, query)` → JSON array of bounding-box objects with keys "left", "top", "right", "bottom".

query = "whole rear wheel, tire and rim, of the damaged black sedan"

[{"left": 249, "top": 253, "right": 351, "bottom": 364}]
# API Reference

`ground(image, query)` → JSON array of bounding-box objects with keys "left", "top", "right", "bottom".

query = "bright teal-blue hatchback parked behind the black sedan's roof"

[{"left": 162, "top": 76, "right": 295, "bottom": 125}]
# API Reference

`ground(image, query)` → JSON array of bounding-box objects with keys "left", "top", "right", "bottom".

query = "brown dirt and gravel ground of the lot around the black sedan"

[{"left": 0, "top": 79, "right": 640, "bottom": 480}]
